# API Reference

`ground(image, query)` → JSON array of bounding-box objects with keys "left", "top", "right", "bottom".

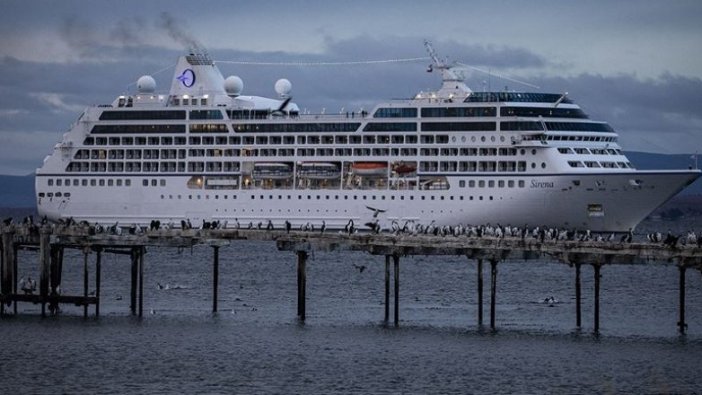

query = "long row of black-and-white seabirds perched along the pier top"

[{"left": 2, "top": 215, "right": 702, "bottom": 248}]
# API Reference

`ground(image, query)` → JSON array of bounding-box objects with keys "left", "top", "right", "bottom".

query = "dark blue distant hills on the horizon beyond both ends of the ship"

[{"left": 0, "top": 152, "right": 702, "bottom": 208}]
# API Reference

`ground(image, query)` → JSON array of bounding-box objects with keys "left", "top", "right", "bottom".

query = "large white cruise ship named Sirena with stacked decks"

[{"left": 36, "top": 43, "right": 700, "bottom": 232}]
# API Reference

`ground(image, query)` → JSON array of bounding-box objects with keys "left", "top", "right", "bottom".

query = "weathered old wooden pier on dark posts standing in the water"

[{"left": 0, "top": 225, "right": 702, "bottom": 333}]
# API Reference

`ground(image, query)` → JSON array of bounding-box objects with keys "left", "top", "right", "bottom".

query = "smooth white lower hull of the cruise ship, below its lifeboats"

[{"left": 37, "top": 171, "right": 699, "bottom": 232}]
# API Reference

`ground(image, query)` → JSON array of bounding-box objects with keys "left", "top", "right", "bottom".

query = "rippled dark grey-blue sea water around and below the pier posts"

[{"left": 0, "top": 241, "right": 702, "bottom": 394}]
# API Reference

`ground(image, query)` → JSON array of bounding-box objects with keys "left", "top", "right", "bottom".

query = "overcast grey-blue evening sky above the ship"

[{"left": 0, "top": 0, "right": 702, "bottom": 175}]
